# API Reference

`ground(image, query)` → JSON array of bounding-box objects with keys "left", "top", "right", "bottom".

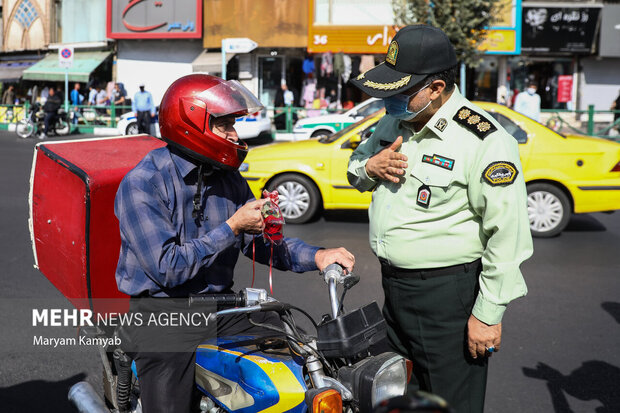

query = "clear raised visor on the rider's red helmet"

[{"left": 197, "top": 80, "right": 263, "bottom": 117}]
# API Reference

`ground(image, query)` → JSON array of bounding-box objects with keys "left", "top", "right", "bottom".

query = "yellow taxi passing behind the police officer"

[{"left": 240, "top": 102, "right": 620, "bottom": 237}]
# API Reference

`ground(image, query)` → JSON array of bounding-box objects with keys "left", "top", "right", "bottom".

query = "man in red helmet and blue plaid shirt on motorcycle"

[{"left": 115, "top": 74, "right": 354, "bottom": 413}]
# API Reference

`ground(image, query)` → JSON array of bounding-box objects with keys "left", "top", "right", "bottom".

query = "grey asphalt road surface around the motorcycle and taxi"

[{"left": 0, "top": 131, "right": 620, "bottom": 413}]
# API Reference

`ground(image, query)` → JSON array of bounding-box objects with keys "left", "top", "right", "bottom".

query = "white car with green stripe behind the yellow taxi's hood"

[{"left": 293, "top": 98, "right": 384, "bottom": 140}]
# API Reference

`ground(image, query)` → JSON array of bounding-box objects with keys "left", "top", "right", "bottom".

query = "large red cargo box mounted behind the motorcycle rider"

[{"left": 29, "top": 135, "right": 165, "bottom": 313}]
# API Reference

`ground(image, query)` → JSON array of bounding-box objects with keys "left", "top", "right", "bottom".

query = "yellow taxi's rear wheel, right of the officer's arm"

[{"left": 527, "top": 183, "right": 571, "bottom": 238}]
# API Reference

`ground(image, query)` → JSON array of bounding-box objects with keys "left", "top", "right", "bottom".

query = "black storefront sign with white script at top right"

[{"left": 521, "top": 3, "right": 601, "bottom": 54}]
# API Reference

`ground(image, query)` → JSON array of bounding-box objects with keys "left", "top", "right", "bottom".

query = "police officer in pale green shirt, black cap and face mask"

[{"left": 348, "top": 25, "right": 532, "bottom": 413}]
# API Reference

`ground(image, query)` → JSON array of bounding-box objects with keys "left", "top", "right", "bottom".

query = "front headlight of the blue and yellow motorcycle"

[{"left": 346, "top": 352, "right": 407, "bottom": 412}]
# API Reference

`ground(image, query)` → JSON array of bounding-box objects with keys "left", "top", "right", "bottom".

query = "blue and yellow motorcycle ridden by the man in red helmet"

[{"left": 69, "top": 264, "right": 412, "bottom": 413}]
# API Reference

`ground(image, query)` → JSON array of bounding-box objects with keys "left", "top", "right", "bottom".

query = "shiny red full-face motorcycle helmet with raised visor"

[{"left": 159, "top": 74, "right": 263, "bottom": 170}]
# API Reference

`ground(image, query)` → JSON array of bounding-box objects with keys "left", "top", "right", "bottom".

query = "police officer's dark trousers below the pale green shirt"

[{"left": 381, "top": 261, "right": 487, "bottom": 413}]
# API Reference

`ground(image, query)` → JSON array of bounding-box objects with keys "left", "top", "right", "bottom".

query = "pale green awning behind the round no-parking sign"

[{"left": 23, "top": 51, "right": 111, "bottom": 82}]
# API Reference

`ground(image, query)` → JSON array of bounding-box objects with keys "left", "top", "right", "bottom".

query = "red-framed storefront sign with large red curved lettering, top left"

[{"left": 107, "top": 0, "right": 202, "bottom": 39}]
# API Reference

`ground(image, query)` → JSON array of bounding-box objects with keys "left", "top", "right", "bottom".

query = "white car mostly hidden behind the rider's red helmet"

[{"left": 116, "top": 110, "right": 274, "bottom": 143}]
